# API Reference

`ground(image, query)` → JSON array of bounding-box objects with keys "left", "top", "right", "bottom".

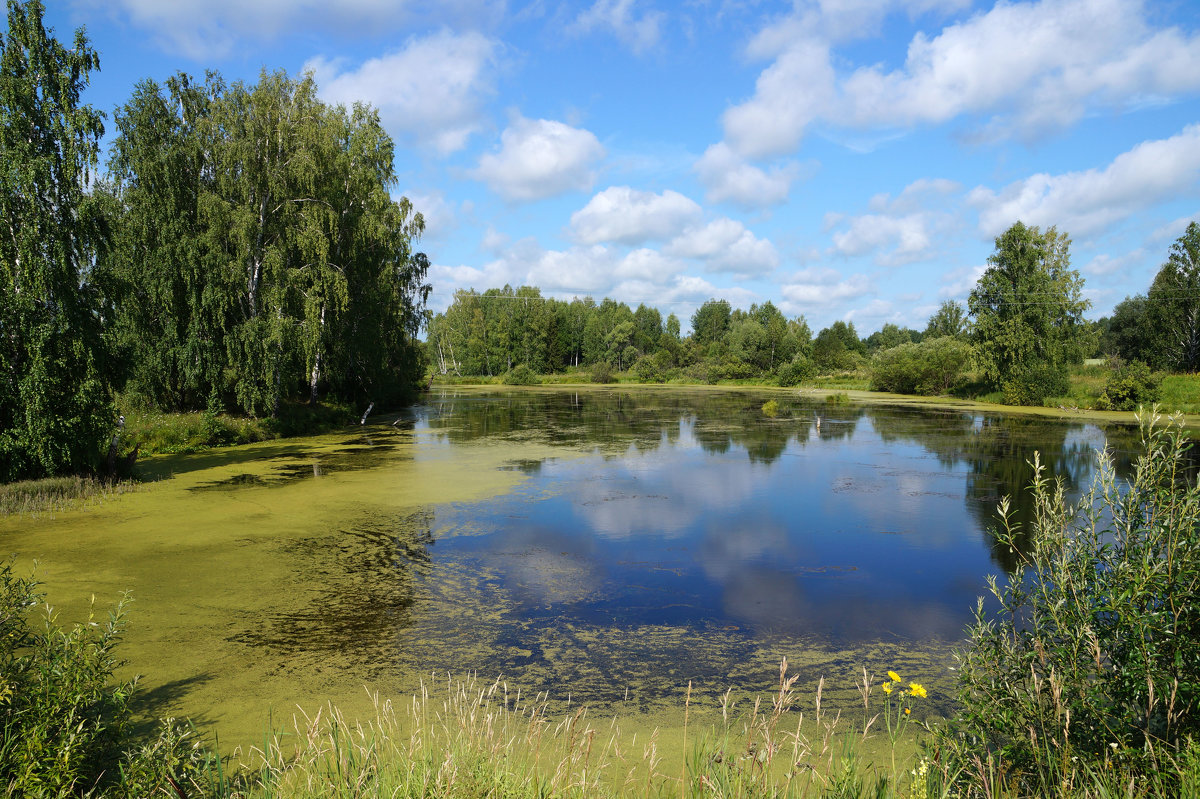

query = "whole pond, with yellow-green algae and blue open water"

[{"left": 0, "top": 386, "right": 1136, "bottom": 744}]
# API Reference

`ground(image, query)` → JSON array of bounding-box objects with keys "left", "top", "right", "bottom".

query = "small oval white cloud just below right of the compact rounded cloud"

[{"left": 571, "top": 186, "right": 703, "bottom": 245}]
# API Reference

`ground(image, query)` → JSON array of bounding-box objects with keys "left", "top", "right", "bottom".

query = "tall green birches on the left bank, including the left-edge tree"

[{"left": 0, "top": 0, "right": 430, "bottom": 480}]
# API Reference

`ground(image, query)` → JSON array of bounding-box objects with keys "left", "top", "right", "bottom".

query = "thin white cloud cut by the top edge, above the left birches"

[{"left": 85, "top": 0, "right": 503, "bottom": 61}]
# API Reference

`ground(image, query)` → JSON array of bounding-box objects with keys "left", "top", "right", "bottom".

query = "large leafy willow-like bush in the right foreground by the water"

[{"left": 942, "top": 415, "right": 1200, "bottom": 795}]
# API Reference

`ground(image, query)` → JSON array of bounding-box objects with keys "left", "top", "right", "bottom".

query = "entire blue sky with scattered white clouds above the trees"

[{"left": 47, "top": 0, "right": 1200, "bottom": 335}]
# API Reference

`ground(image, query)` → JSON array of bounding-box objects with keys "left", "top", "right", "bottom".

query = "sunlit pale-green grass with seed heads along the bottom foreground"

[{"left": 194, "top": 660, "right": 917, "bottom": 799}]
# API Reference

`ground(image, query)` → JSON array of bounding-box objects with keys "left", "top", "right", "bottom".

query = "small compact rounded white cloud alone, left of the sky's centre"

[{"left": 473, "top": 118, "right": 605, "bottom": 200}]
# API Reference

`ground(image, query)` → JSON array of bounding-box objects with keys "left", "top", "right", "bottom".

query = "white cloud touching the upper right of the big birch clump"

[{"left": 304, "top": 31, "right": 499, "bottom": 154}]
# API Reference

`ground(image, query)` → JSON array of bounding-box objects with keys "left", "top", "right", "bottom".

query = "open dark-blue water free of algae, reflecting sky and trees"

[{"left": 418, "top": 391, "right": 1132, "bottom": 667}]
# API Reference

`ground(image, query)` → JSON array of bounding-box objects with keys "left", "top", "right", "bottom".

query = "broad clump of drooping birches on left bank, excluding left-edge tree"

[{"left": 98, "top": 72, "right": 428, "bottom": 415}]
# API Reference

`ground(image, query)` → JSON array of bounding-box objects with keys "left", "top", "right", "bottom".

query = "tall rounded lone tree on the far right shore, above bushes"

[{"left": 968, "top": 222, "right": 1090, "bottom": 404}]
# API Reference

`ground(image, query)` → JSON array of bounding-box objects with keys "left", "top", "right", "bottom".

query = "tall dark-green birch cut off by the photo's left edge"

[{"left": 0, "top": 0, "right": 115, "bottom": 481}]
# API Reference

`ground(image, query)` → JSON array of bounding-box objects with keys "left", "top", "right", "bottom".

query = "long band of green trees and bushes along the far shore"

[{"left": 427, "top": 222, "right": 1200, "bottom": 404}]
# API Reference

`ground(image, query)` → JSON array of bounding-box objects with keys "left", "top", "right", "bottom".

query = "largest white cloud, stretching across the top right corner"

[{"left": 722, "top": 0, "right": 1200, "bottom": 157}]
